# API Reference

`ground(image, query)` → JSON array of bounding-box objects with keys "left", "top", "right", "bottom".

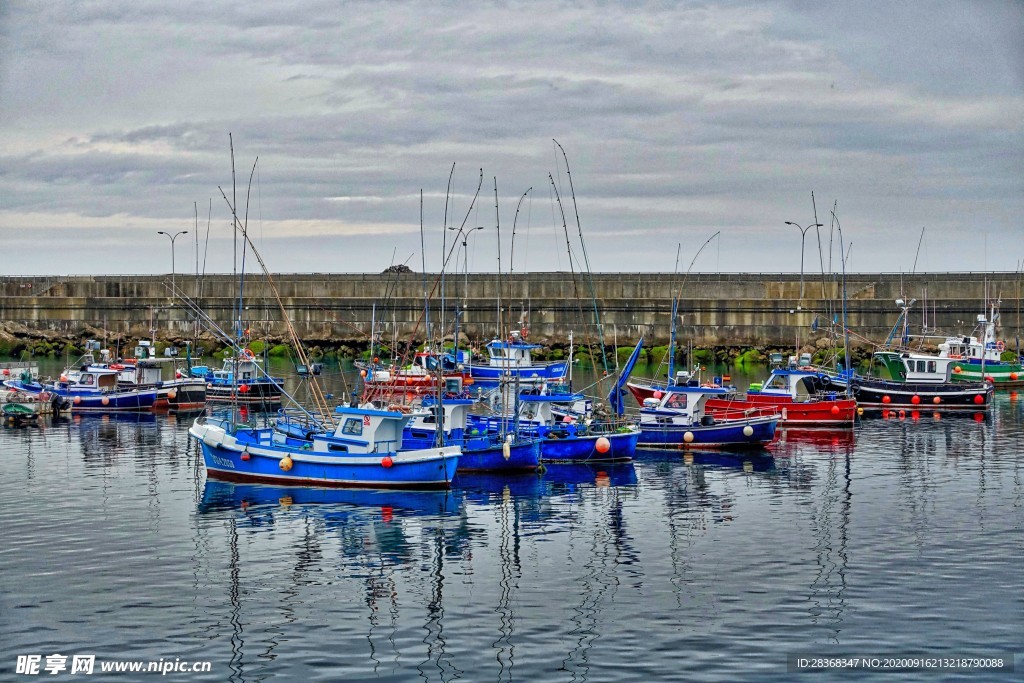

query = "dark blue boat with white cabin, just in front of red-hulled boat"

[{"left": 639, "top": 385, "right": 779, "bottom": 449}]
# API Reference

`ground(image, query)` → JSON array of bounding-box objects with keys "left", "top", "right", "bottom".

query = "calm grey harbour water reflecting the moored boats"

[{"left": 0, "top": 360, "right": 1024, "bottom": 681}]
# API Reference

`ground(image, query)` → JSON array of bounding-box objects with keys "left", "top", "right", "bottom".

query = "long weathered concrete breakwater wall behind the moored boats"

[{"left": 0, "top": 272, "right": 1021, "bottom": 356}]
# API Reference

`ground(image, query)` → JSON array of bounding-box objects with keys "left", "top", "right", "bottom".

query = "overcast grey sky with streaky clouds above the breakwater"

[{"left": 0, "top": 0, "right": 1024, "bottom": 274}]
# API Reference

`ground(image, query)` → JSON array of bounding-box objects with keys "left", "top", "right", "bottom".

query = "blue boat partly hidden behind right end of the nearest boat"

[{"left": 402, "top": 398, "right": 541, "bottom": 472}]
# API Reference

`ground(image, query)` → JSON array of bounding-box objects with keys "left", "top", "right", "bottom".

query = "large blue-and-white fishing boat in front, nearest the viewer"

[{"left": 188, "top": 407, "right": 461, "bottom": 488}]
